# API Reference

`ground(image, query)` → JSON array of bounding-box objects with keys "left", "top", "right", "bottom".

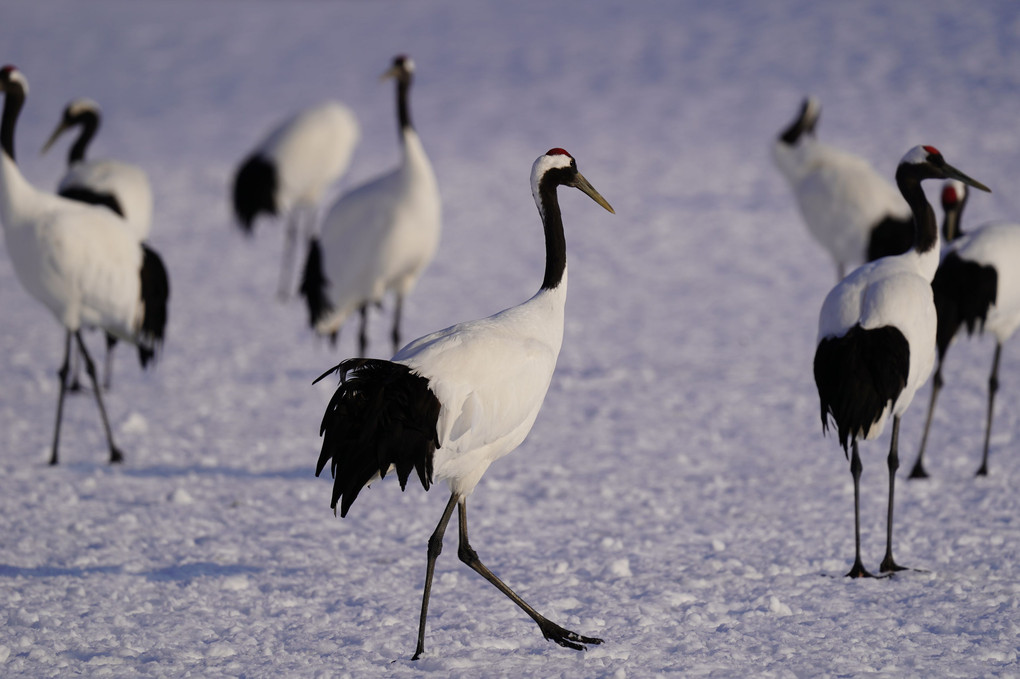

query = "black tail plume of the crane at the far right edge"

[{"left": 931, "top": 252, "right": 999, "bottom": 359}]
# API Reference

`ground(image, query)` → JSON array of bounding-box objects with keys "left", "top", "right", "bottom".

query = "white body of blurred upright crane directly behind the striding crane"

[{"left": 315, "top": 127, "right": 442, "bottom": 335}]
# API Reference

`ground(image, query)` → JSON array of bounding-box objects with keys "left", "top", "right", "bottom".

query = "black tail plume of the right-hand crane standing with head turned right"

[{"left": 815, "top": 324, "right": 910, "bottom": 453}]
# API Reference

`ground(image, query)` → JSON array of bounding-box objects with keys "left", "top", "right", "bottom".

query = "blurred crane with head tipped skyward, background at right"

[{"left": 772, "top": 97, "right": 914, "bottom": 280}]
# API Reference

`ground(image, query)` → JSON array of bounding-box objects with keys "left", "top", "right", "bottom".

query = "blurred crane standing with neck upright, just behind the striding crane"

[{"left": 301, "top": 55, "right": 441, "bottom": 356}]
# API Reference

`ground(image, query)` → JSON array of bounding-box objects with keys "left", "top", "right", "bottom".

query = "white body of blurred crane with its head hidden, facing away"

[{"left": 257, "top": 101, "right": 361, "bottom": 214}]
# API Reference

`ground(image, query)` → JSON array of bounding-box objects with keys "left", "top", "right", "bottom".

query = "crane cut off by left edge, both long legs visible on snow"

[{"left": 0, "top": 66, "right": 169, "bottom": 465}]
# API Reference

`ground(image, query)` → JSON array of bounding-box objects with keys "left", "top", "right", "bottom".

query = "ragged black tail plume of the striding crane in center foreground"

[{"left": 315, "top": 359, "right": 440, "bottom": 516}]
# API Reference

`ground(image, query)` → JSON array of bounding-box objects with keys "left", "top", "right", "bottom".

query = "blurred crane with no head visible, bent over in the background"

[{"left": 233, "top": 101, "right": 361, "bottom": 299}]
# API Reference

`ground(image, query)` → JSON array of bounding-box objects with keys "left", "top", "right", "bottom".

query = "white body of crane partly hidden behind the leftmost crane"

[{"left": 57, "top": 159, "right": 152, "bottom": 242}]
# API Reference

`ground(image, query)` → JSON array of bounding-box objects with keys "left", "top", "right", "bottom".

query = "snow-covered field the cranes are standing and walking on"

[{"left": 0, "top": 0, "right": 1020, "bottom": 678}]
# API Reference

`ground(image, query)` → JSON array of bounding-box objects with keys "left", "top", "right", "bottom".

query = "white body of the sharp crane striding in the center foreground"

[{"left": 393, "top": 272, "right": 567, "bottom": 498}]
